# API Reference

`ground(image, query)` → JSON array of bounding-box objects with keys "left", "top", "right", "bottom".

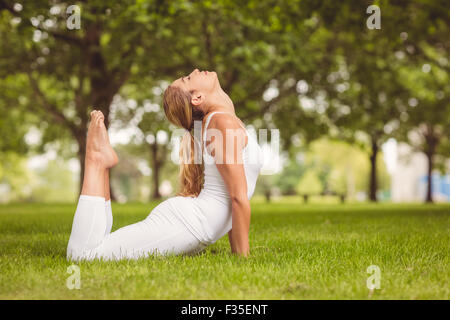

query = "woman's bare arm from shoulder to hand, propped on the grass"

[{"left": 208, "top": 114, "right": 251, "bottom": 257}]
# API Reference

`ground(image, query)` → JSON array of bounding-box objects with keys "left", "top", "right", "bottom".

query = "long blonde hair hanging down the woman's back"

[{"left": 163, "top": 86, "right": 204, "bottom": 197}]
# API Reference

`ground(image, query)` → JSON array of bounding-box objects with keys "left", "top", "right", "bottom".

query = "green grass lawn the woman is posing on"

[{"left": 0, "top": 202, "right": 450, "bottom": 299}]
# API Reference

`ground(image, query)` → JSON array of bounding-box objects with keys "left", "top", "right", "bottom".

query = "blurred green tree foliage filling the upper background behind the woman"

[{"left": 0, "top": 0, "right": 450, "bottom": 200}]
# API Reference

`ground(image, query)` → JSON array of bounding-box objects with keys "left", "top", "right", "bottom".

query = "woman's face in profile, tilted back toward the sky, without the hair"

[{"left": 172, "top": 69, "right": 220, "bottom": 96}]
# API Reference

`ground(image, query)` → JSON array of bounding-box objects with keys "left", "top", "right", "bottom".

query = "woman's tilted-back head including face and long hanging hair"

[{"left": 163, "top": 69, "right": 221, "bottom": 196}]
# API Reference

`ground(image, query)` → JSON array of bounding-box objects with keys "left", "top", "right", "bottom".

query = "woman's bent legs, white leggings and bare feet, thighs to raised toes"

[{"left": 67, "top": 114, "right": 205, "bottom": 260}]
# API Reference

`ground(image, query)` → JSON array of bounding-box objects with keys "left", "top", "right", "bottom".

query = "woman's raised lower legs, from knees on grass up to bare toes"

[{"left": 67, "top": 111, "right": 118, "bottom": 259}]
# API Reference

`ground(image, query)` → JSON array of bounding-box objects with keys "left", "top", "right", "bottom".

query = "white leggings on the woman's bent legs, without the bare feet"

[{"left": 67, "top": 195, "right": 207, "bottom": 261}]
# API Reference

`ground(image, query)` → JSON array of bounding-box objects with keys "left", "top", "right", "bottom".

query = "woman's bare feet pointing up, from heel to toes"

[{"left": 86, "top": 110, "right": 119, "bottom": 168}]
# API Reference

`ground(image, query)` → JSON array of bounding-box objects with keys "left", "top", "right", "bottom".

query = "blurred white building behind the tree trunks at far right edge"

[{"left": 390, "top": 143, "right": 450, "bottom": 202}]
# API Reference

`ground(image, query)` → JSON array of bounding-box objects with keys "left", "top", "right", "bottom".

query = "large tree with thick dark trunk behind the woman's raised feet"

[{"left": 0, "top": 1, "right": 192, "bottom": 192}]
